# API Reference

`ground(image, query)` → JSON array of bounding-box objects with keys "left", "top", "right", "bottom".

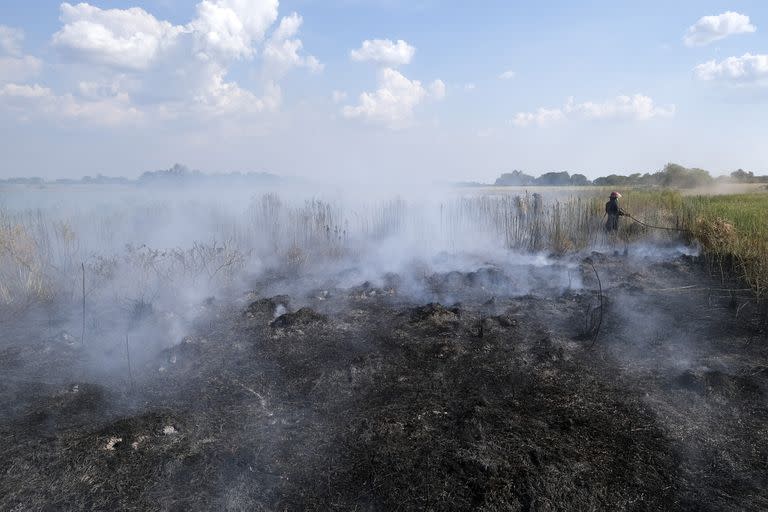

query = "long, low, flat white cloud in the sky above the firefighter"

[{"left": 512, "top": 94, "right": 675, "bottom": 127}]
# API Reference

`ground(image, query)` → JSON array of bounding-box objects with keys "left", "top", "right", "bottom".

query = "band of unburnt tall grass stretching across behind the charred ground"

[{"left": 0, "top": 188, "right": 768, "bottom": 316}]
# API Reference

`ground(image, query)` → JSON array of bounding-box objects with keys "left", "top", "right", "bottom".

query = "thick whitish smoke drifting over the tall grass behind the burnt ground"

[{"left": 0, "top": 180, "right": 688, "bottom": 388}]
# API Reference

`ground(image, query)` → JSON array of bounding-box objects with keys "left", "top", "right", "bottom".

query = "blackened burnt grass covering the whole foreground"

[{"left": 0, "top": 250, "right": 768, "bottom": 511}]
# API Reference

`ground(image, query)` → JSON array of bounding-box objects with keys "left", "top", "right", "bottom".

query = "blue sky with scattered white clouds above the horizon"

[{"left": 0, "top": 0, "right": 768, "bottom": 184}]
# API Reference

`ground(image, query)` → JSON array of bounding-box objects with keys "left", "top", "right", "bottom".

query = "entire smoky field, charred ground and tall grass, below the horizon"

[{"left": 0, "top": 183, "right": 768, "bottom": 511}]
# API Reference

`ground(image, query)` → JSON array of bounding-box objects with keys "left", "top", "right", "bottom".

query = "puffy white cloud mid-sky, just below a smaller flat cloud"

[{"left": 342, "top": 68, "right": 445, "bottom": 128}]
